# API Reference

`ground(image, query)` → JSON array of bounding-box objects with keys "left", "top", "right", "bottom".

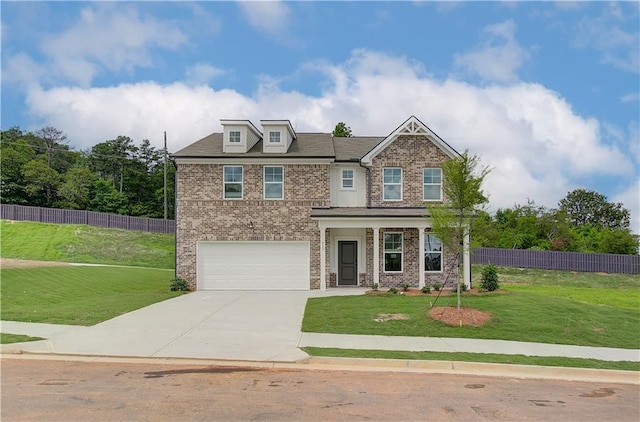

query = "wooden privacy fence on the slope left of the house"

[{"left": 0, "top": 204, "right": 176, "bottom": 233}]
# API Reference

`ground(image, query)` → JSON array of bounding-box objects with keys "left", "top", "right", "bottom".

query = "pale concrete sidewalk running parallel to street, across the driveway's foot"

[{"left": 1, "top": 321, "right": 640, "bottom": 362}]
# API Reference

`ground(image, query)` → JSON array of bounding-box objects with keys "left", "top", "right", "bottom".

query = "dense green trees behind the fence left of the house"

[{"left": 0, "top": 126, "right": 175, "bottom": 218}]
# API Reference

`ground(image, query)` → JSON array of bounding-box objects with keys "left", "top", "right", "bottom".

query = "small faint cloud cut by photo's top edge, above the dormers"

[{"left": 238, "top": 0, "right": 291, "bottom": 35}]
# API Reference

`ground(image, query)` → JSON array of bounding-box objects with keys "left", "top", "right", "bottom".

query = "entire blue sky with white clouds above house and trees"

[{"left": 0, "top": 1, "right": 640, "bottom": 232}]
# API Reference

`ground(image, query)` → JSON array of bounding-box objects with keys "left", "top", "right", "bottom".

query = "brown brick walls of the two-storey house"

[{"left": 176, "top": 120, "right": 458, "bottom": 289}]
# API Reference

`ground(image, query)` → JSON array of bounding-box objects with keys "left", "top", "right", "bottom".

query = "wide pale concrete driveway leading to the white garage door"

[{"left": 3, "top": 291, "right": 324, "bottom": 362}]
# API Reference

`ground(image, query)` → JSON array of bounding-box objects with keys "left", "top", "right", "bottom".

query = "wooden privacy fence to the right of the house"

[{"left": 471, "top": 248, "right": 640, "bottom": 274}]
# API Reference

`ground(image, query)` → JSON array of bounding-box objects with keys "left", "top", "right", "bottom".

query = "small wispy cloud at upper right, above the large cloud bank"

[{"left": 454, "top": 20, "right": 530, "bottom": 82}]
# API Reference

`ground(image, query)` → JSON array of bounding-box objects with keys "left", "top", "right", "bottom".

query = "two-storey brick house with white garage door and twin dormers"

[{"left": 173, "top": 116, "right": 470, "bottom": 290}]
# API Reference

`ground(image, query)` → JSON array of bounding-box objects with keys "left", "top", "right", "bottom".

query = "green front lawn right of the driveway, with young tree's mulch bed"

[{"left": 302, "top": 286, "right": 640, "bottom": 349}]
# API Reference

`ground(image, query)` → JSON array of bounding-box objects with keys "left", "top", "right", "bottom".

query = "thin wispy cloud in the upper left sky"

[{"left": 30, "top": 3, "right": 186, "bottom": 86}]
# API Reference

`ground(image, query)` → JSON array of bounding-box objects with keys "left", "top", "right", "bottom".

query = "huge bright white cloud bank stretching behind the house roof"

[{"left": 22, "top": 50, "right": 638, "bottom": 224}]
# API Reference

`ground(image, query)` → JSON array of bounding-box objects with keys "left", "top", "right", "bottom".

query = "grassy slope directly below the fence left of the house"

[{"left": 0, "top": 220, "right": 175, "bottom": 268}]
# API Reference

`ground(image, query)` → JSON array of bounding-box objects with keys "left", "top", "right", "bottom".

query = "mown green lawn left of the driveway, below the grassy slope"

[{"left": 0, "top": 266, "right": 182, "bottom": 325}]
